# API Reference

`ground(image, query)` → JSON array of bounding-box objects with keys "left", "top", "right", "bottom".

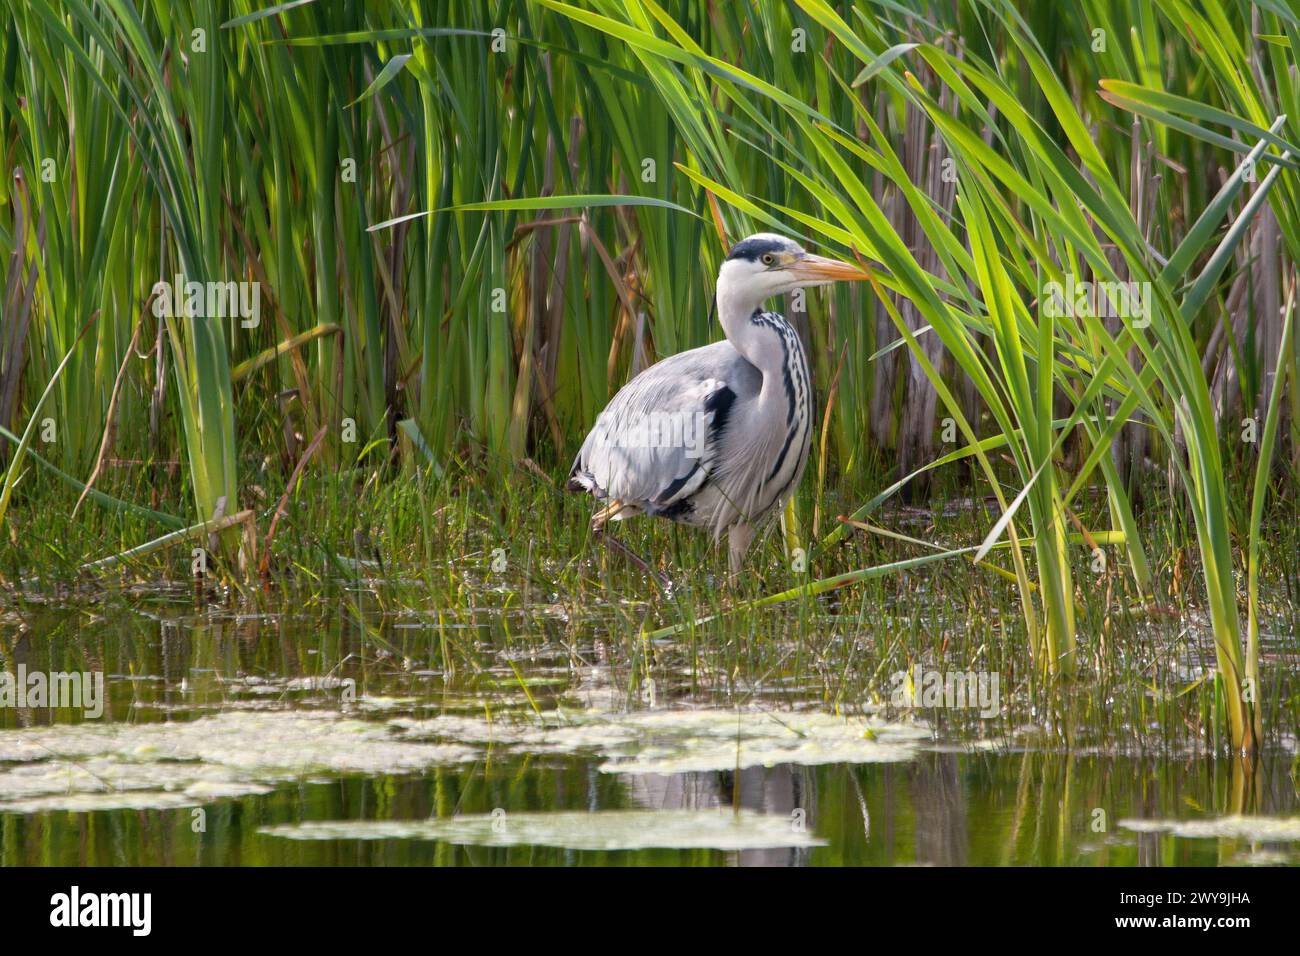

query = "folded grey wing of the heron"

[{"left": 569, "top": 342, "right": 762, "bottom": 516}]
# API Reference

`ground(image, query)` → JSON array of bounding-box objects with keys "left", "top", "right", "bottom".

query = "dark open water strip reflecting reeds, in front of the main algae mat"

[{"left": 0, "top": 753, "right": 1300, "bottom": 866}]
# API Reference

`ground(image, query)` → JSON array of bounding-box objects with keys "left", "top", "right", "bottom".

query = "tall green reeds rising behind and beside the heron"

[{"left": 0, "top": 0, "right": 1300, "bottom": 749}]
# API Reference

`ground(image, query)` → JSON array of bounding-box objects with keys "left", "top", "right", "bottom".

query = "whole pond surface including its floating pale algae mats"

[{"left": 0, "top": 587, "right": 1300, "bottom": 866}]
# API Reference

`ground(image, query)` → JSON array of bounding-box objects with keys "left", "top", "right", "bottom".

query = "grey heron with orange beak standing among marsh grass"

[{"left": 568, "top": 233, "right": 867, "bottom": 574}]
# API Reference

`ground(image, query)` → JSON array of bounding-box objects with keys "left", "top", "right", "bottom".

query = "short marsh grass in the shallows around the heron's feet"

[{"left": 0, "top": 444, "right": 1300, "bottom": 754}]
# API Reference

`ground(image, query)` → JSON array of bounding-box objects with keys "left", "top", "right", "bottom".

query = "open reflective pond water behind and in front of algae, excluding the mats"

[{"left": 0, "top": 609, "right": 1300, "bottom": 866}]
